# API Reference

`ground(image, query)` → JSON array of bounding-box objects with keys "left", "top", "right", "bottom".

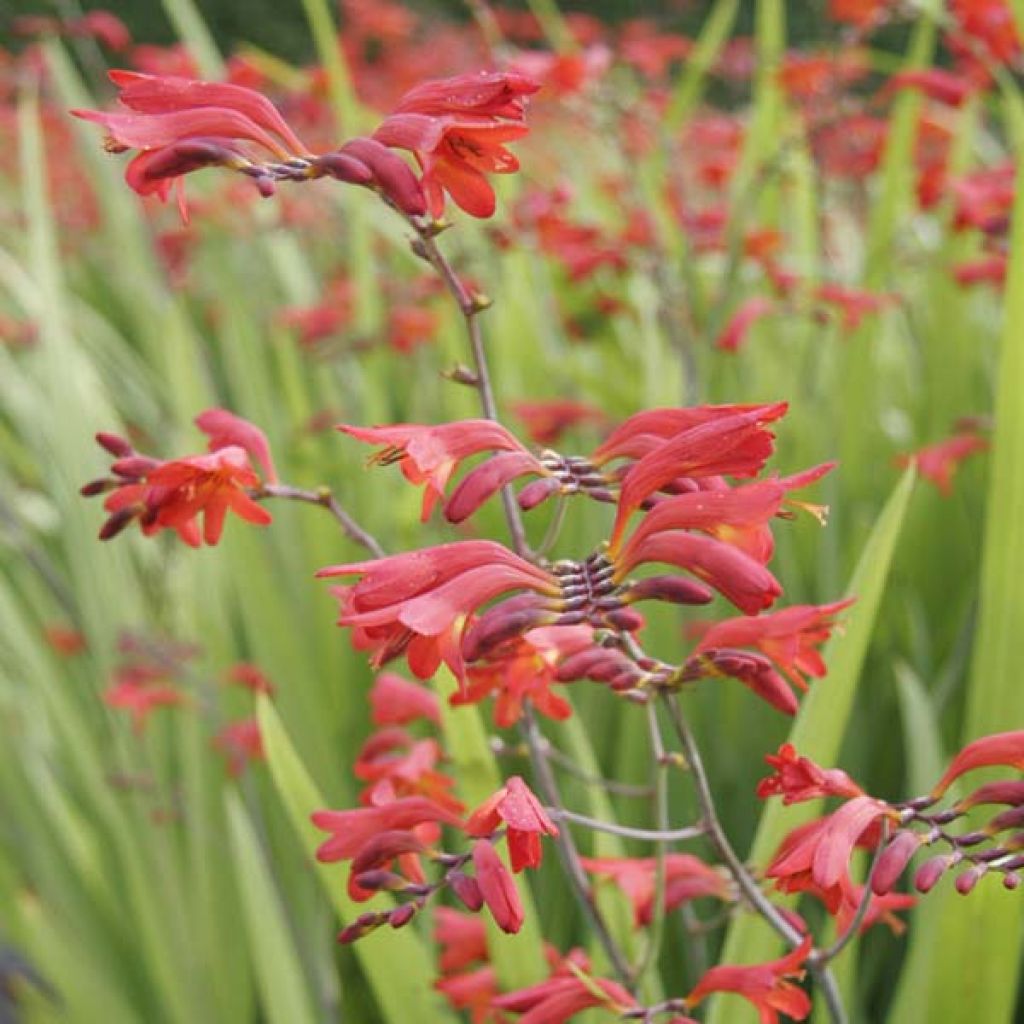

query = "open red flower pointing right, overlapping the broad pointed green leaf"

[{"left": 693, "top": 598, "right": 854, "bottom": 690}]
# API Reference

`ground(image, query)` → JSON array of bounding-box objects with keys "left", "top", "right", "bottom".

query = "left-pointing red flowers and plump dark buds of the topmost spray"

[{"left": 71, "top": 71, "right": 426, "bottom": 221}]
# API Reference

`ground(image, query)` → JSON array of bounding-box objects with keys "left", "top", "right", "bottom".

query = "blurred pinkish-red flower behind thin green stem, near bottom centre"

[{"left": 581, "top": 853, "right": 729, "bottom": 928}]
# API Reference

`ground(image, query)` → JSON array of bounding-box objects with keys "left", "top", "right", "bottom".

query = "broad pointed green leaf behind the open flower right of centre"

[{"left": 708, "top": 468, "right": 914, "bottom": 1024}]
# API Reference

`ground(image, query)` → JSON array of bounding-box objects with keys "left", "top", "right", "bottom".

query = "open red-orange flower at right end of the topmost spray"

[{"left": 373, "top": 72, "right": 540, "bottom": 218}]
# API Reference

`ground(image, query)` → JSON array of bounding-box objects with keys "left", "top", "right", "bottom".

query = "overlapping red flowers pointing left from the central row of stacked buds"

[{"left": 316, "top": 541, "right": 560, "bottom": 680}]
